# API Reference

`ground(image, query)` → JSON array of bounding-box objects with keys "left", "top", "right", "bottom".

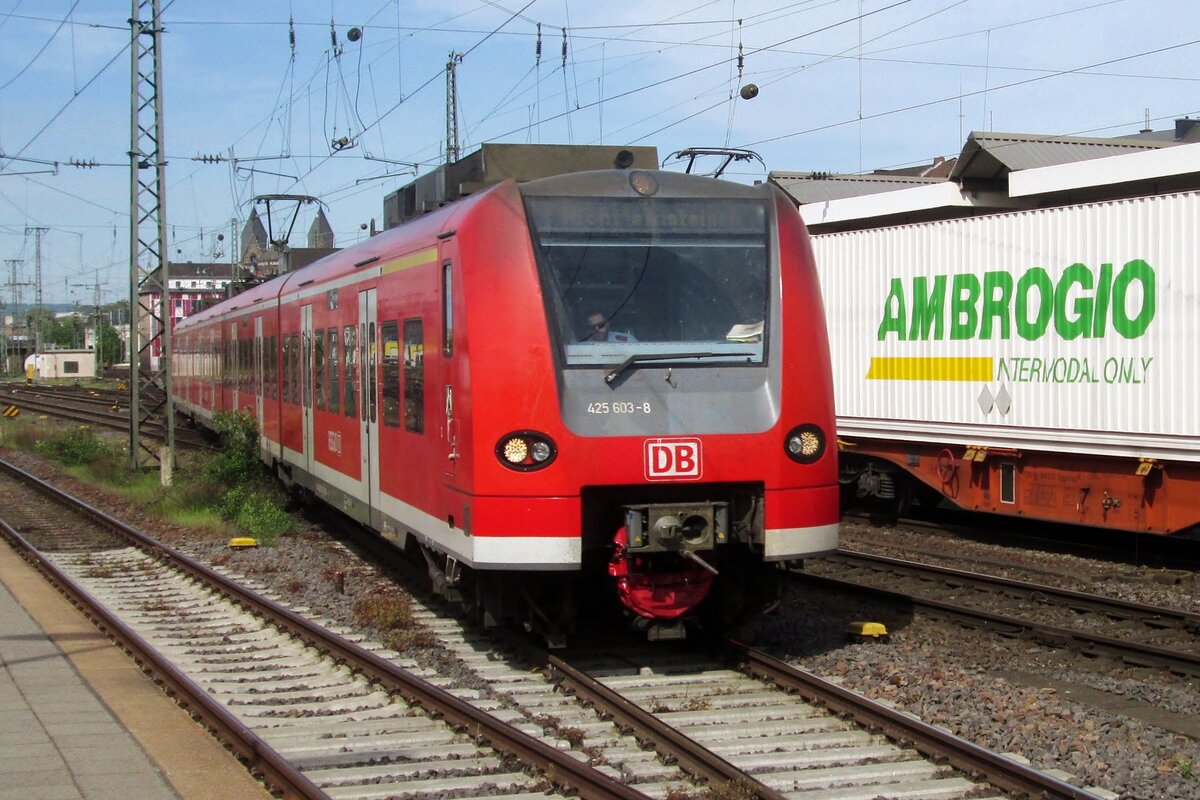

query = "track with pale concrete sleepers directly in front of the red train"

[{"left": 550, "top": 642, "right": 1097, "bottom": 800}]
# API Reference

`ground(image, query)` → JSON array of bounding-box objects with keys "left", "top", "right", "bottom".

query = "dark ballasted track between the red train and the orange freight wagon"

[{"left": 798, "top": 549, "right": 1200, "bottom": 676}]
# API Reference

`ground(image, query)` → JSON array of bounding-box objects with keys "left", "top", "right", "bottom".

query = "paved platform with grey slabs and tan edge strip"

[{"left": 0, "top": 542, "right": 270, "bottom": 800}]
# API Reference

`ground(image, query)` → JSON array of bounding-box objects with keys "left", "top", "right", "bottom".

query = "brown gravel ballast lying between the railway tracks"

[{"left": 0, "top": 443, "right": 1200, "bottom": 800}]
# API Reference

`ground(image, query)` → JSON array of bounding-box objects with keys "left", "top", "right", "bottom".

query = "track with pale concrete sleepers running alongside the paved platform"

[{"left": 0, "top": 462, "right": 644, "bottom": 800}]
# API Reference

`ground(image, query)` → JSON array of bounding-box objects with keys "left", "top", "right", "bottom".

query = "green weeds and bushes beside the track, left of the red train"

[{"left": 0, "top": 413, "right": 293, "bottom": 546}]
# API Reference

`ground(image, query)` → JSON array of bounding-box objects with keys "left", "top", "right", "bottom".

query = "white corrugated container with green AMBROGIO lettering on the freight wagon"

[{"left": 812, "top": 192, "right": 1200, "bottom": 461}]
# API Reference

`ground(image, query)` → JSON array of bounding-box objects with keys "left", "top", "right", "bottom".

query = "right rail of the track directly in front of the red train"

[{"left": 722, "top": 639, "right": 1100, "bottom": 800}]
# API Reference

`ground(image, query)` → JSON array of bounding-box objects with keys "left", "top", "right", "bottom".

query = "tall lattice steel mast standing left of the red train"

[{"left": 130, "top": 0, "right": 175, "bottom": 474}]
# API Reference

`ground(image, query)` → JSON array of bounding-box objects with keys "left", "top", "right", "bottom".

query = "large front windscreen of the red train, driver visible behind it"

[{"left": 526, "top": 197, "right": 770, "bottom": 366}]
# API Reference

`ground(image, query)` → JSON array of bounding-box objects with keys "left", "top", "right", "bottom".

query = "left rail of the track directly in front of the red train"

[{"left": 545, "top": 654, "right": 786, "bottom": 800}]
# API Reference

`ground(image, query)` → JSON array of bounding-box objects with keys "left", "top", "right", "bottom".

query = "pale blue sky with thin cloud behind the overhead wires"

[{"left": 0, "top": 0, "right": 1200, "bottom": 305}]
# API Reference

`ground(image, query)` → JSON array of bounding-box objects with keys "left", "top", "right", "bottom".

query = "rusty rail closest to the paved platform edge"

[{"left": 0, "top": 519, "right": 329, "bottom": 800}]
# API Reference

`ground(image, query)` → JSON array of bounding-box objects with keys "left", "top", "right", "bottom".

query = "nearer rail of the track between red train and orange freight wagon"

[{"left": 793, "top": 572, "right": 1200, "bottom": 675}]
